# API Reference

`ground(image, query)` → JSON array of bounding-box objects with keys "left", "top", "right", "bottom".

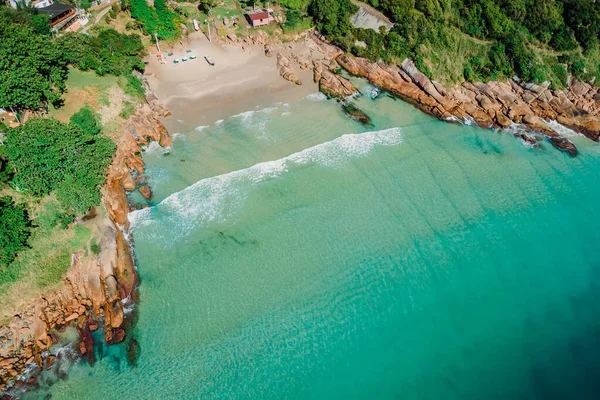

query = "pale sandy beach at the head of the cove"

[{"left": 146, "top": 32, "right": 318, "bottom": 133}]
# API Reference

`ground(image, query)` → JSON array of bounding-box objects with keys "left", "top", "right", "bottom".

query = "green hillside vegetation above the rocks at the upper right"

[{"left": 308, "top": 0, "right": 600, "bottom": 87}]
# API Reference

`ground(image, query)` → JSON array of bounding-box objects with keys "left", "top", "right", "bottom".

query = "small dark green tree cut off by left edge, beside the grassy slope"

[{"left": 0, "top": 197, "right": 30, "bottom": 272}]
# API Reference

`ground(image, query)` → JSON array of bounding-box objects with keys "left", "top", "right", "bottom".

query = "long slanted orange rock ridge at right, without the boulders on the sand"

[{"left": 336, "top": 49, "right": 600, "bottom": 156}]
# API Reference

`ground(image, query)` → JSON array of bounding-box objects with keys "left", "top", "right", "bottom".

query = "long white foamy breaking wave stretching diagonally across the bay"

[{"left": 129, "top": 128, "right": 402, "bottom": 234}]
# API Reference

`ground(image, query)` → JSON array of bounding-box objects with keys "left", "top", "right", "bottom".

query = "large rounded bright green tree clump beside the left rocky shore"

[{"left": 4, "top": 114, "right": 115, "bottom": 214}]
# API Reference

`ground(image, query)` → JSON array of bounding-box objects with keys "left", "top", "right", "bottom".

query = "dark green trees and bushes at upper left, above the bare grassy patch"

[{"left": 0, "top": 7, "right": 146, "bottom": 110}]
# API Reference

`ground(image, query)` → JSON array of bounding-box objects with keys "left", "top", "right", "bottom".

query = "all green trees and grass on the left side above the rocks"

[{"left": 0, "top": 0, "right": 157, "bottom": 296}]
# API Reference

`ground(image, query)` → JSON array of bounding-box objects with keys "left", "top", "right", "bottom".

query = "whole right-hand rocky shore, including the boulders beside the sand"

[{"left": 237, "top": 33, "right": 600, "bottom": 156}]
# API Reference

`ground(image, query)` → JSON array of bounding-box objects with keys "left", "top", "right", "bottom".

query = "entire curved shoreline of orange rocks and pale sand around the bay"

[{"left": 0, "top": 24, "right": 600, "bottom": 393}]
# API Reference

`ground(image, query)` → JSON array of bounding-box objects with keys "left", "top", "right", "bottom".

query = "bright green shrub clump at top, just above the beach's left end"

[{"left": 125, "top": 0, "right": 181, "bottom": 40}]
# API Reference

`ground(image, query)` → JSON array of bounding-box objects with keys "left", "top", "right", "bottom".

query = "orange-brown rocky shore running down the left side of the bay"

[{"left": 0, "top": 86, "right": 172, "bottom": 399}]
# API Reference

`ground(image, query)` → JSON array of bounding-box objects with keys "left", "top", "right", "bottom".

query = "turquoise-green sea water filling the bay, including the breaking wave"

[{"left": 32, "top": 79, "right": 600, "bottom": 399}]
